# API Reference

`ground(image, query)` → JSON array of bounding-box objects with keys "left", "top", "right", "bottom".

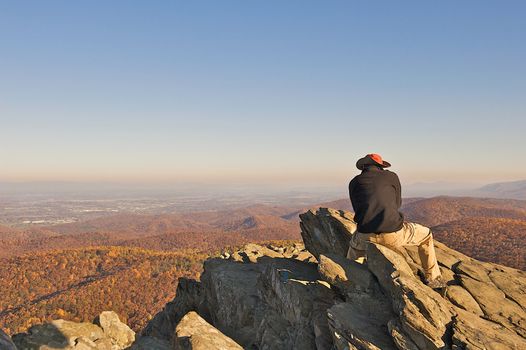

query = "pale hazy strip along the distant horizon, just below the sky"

[{"left": 0, "top": 179, "right": 526, "bottom": 200}]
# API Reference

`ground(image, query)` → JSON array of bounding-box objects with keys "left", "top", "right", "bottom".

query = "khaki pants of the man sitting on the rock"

[{"left": 347, "top": 222, "right": 440, "bottom": 280}]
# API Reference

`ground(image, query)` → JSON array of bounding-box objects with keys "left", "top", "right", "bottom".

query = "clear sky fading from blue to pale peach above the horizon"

[{"left": 0, "top": 0, "right": 526, "bottom": 189}]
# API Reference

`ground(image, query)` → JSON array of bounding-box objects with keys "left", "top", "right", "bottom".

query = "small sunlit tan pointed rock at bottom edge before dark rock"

[{"left": 174, "top": 311, "right": 243, "bottom": 350}]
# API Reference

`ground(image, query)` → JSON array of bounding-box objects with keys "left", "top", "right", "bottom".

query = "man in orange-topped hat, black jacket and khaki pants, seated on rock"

[{"left": 347, "top": 154, "right": 445, "bottom": 289}]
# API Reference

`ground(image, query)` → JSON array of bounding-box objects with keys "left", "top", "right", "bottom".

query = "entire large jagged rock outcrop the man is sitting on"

[{"left": 139, "top": 209, "right": 526, "bottom": 350}]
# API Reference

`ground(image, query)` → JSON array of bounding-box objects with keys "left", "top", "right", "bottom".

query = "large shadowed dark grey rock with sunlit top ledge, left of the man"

[{"left": 142, "top": 244, "right": 334, "bottom": 349}]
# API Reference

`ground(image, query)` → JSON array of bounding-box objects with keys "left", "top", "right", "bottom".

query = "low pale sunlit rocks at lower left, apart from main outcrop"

[{"left": 12, "top": 311, "right": 135, "bottom": 350}]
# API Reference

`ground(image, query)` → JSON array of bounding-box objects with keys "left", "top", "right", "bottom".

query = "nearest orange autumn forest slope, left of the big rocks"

[{"left": 0, "top": 247, "right": 206, "bottom": 334}]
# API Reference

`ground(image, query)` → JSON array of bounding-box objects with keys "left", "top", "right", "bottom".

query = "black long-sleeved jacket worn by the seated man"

[{"left": 349, "top": 165, "right": 404, "bottom": 233}]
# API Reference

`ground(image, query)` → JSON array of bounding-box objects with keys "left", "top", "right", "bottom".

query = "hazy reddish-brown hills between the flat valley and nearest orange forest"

[{"left": 0, "top": 205, "right": 306, "bottom": 257}]
